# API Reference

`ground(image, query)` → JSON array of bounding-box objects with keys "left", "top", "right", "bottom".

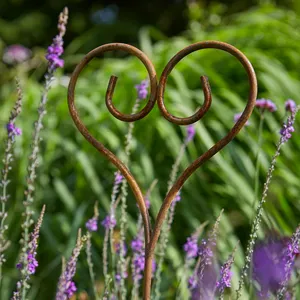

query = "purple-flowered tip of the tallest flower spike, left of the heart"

[{"left": 46, "top": 8, "right": 68, "bottom": 73}]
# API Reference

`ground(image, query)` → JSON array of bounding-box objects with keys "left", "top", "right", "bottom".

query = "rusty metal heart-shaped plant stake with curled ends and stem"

[{"left": 68, "top": 41, "right": 257, "bottom": 300}]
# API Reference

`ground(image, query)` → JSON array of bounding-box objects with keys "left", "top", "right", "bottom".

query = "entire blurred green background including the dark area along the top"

[{"left": 0, "top": 0, "right": 300, "bottom": 299}]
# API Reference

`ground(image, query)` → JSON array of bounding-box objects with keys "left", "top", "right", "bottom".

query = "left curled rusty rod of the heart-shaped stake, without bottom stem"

[{"left": 68, "top": 43, "right": 157, "bottom": 248}]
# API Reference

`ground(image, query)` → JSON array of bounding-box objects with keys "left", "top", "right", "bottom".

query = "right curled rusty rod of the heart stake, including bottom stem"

[{"left": 144, "top": 41, "right": 257, "bottom": 299}]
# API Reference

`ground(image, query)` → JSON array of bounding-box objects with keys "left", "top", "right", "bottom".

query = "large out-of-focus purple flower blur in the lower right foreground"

[{"left": 253, "top": 239, "right": 285, "bottom": 299}]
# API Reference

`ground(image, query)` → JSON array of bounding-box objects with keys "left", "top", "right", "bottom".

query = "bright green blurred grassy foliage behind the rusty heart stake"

[{"left": 0, "top": 6, "right": 300, "bottom": 299}]
